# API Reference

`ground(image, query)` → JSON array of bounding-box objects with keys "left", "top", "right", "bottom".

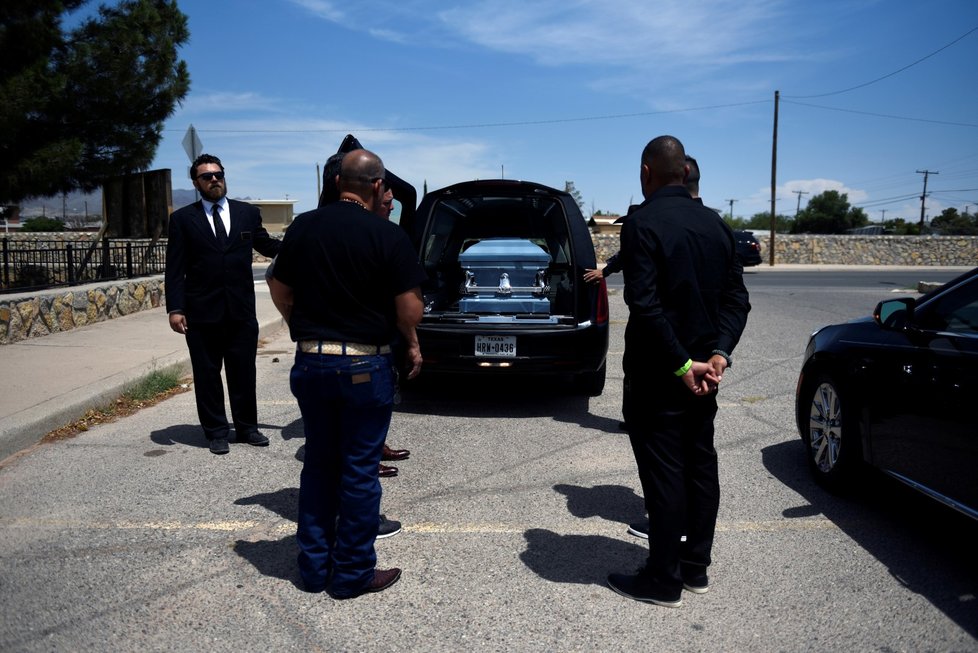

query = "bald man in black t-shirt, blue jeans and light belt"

[{"left": 270, "top": 150, "right": 425, "bottom": 598}]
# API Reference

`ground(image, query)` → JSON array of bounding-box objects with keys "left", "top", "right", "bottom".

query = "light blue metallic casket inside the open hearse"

[{"left": 458, "top": 238, "right": 550, "bottom": 315}]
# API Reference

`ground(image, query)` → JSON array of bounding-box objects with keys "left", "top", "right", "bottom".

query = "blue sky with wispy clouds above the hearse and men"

[{"left": 147, "top": 0, "right": 978, "bottom": 221}]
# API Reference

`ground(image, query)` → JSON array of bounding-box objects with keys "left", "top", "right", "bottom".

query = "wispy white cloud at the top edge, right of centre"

[{"left": 437, "top": 0, "right": 785, "bottom": 71}]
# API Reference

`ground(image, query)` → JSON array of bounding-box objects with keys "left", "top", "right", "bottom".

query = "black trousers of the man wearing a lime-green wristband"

[{"left": 622, "top": 374, "right": 720, "bottom": 592}]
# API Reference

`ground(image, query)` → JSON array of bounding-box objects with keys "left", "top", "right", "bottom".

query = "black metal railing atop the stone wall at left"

[{"left": 0, "top": 238, "right": 166, "bottom": 293}]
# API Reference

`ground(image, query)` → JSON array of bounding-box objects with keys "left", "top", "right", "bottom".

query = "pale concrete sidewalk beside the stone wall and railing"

[{"left": 0, "top": 266, "right": 285, "bottom": 461}]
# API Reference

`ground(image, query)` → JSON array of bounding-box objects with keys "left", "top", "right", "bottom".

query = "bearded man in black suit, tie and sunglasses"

[{"left": 166, "top": 154, "right": 281, "bottom": 454}]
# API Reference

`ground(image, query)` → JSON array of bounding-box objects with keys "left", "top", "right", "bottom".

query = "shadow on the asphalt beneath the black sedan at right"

[{"left": 761, "top": 440, "right": 978, "bottom": 636}]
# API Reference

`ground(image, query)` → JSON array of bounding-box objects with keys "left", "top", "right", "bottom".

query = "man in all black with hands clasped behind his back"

[{"left": 608, "top": 136, "right": 750, "bottom": 607}]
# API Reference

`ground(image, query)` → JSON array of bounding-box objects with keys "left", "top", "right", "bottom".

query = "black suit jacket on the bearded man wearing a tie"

[{"left": 166, "top": 200, "right": 282, "bottom": 323}]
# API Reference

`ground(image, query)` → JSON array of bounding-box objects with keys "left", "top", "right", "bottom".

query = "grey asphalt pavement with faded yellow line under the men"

[{"left": 0, "top": 274, "right": 978, "bottom": 651}]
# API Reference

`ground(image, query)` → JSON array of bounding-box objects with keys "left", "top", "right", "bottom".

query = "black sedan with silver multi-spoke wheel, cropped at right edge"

[{"left": 795, "top": 268, "right": 978, "bottom": 519}]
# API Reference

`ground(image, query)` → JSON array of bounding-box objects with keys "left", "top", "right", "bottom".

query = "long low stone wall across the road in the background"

[{"left": 591, "top": 231, "right": 978, "bottom": 267}]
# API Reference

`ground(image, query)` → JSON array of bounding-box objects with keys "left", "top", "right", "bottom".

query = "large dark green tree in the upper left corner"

[{"left": 0, "top": 0, "right": 190, "bottom": 203}]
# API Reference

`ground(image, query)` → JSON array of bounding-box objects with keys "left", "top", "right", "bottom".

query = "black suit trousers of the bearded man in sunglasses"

[{"left": 187, "top": 318, "right": 258, "bottom": 440}]
